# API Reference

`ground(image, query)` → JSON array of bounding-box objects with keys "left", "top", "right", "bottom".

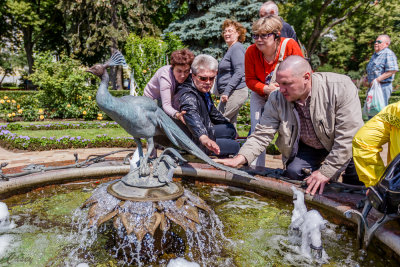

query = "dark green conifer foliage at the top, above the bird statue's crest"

[{"left": 59, "top": 0, "right": 169, "bottom": 65}]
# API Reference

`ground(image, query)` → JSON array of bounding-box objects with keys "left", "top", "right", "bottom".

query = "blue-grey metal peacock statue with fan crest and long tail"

[{"left": 87, "top": 51, "right": 254, "bottom": 179}]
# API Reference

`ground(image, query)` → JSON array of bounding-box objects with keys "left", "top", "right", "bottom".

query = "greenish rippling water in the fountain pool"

[{"left": 0, "top": 178, "right": 394, "bottom": 267}]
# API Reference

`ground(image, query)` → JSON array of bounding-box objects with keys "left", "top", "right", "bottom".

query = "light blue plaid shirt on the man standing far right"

[{"left": 367, "top": 47, "right": 399, "bottom": 83}]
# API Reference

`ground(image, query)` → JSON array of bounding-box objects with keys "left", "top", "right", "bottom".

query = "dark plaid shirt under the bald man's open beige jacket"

[{"left": 294, "top": 96, "right": 324, "bottom": 149}]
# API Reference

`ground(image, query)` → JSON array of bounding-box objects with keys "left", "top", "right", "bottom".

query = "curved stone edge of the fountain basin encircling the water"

[{"left": 0, "top": 161, "right": 400, "bottom": 257}]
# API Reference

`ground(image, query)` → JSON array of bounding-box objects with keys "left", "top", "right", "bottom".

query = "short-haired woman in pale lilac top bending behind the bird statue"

[{"left": 143, "top": 48, "right": 194, "bottom": 123}]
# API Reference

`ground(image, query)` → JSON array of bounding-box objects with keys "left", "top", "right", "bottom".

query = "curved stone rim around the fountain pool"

[{"left": 0, "top": 163, "right": 400, "bottom": 256}]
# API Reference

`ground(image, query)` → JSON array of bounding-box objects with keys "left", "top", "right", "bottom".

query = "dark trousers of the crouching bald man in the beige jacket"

[{"left": 284, "top": 142, "right": 363, "bottom": 185}]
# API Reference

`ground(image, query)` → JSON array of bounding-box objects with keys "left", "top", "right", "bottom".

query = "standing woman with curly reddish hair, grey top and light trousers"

[{"left": 216, "top": 19, "right": 248, "bottom": 129}]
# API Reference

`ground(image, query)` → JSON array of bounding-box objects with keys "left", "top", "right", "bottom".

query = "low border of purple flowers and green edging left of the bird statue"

[{"left": 0, "top": 130, "right": 136, "bottom": 151}]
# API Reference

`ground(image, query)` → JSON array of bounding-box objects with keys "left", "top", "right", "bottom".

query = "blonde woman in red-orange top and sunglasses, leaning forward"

[{"left": 245, "top": 15, "right": 303, "bottom": 167}]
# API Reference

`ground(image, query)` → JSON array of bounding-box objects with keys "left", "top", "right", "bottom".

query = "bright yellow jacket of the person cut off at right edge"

[{"left": 353, "top": 101, "right": 400, "bottom": 187}]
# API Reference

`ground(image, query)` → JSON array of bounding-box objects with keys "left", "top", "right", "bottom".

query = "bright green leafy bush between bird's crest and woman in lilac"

[{"left": 125, "top": 33, "right": 184, "bottom": 95}]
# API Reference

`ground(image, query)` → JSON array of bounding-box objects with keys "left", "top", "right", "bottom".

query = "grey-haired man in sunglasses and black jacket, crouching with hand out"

[{"left": 175, "top": 55, "right": 239, "bottom": 157}]
